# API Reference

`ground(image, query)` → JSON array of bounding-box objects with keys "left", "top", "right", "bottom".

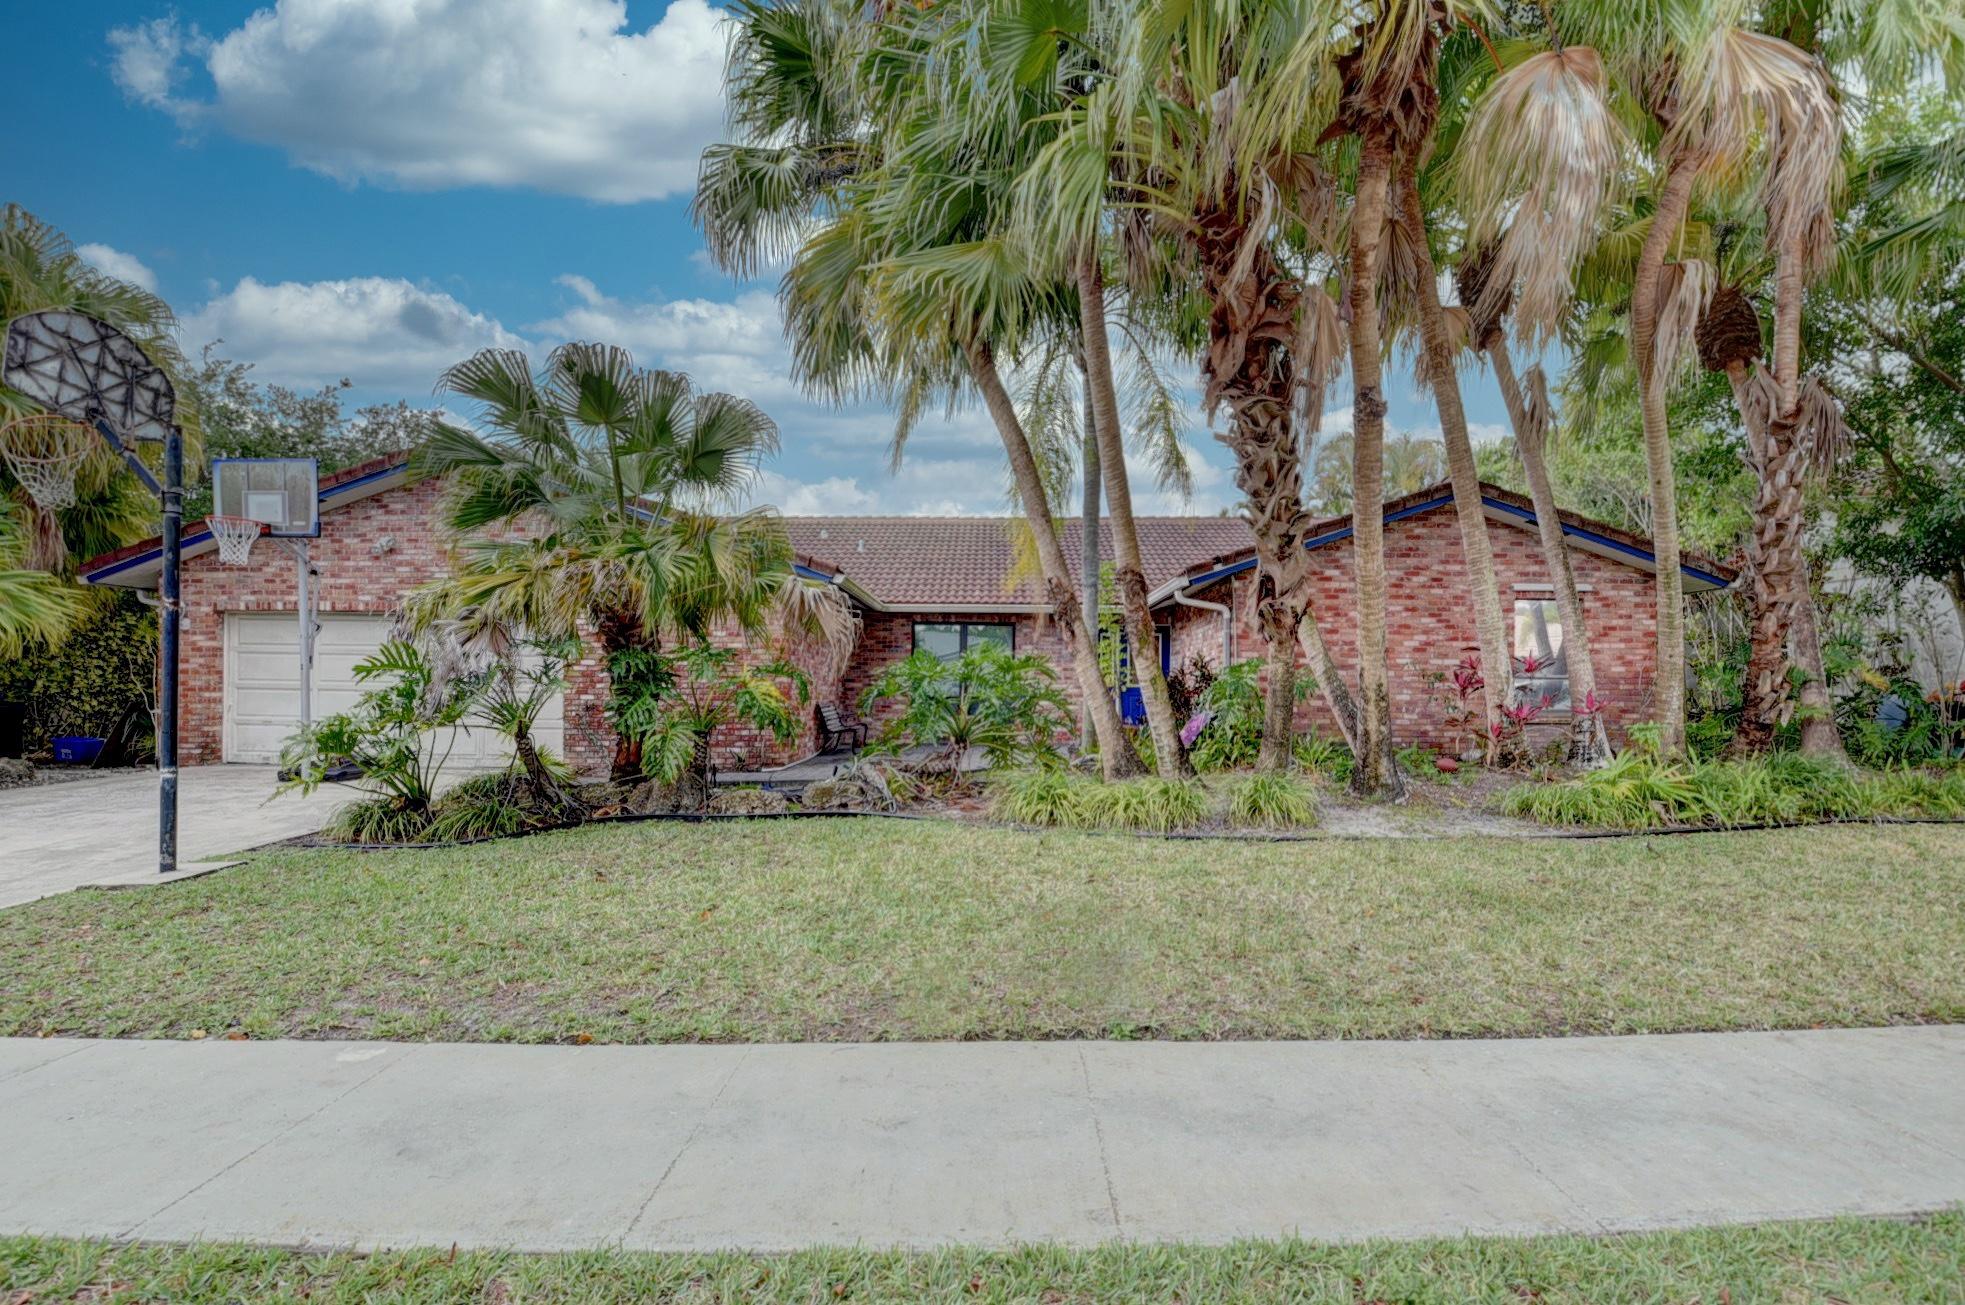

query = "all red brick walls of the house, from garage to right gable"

[{"left": 181, "top": 482, "right": 1653, "bottom": 772}]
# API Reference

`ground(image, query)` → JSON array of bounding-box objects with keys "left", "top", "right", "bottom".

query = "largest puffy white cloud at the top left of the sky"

[{"left": 110, "top": 0, "right": 723, "bottom": 202}]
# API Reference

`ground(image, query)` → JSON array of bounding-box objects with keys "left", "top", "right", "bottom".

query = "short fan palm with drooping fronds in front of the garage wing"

[{"left": 411, "top": 344, "right": 849, "bottom": 778}]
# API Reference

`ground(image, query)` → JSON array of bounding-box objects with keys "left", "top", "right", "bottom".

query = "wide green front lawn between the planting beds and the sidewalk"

[{"left": 0, "top": 820, "right": 1965, "bottom": 1042}]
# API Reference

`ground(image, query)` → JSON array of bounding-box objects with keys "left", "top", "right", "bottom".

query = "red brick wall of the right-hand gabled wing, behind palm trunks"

[{"left": 1173, "top": 509, "right": 1655, "bottom": 747}]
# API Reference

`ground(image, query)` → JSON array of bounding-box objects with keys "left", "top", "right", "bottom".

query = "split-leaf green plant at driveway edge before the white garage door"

[{"left": 279, "top": 639, "right": 481, "bottom": 841}]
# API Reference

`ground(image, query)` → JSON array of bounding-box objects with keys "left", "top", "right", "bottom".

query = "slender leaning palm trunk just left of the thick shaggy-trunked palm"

[{"left": 1077, "top": 248, "right": 1195, "bottom": 778}]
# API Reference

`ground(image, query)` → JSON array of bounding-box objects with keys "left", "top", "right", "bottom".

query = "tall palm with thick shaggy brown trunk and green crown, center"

[{"left": 1002, "top": 0, "right": 1399, "bottom": 768}]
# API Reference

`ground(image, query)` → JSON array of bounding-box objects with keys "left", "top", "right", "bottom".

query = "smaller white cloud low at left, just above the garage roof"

[{"left": 181, "top": 277, "right": 531, "bottom": 395}]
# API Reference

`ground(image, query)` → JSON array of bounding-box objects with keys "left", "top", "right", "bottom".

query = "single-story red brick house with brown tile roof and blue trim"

[{"left": 81, "top": 456, "right": 1735, "bottom": 770}]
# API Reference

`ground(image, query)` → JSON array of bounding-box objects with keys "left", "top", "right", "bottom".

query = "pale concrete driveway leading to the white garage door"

[{"left": 0, "top": 766, "right": 354, "bottom": 908}]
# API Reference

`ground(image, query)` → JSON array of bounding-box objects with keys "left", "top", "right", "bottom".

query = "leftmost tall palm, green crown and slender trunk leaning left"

[{"left": 696, "top": 0, "right": 1138, "bottom": 778}]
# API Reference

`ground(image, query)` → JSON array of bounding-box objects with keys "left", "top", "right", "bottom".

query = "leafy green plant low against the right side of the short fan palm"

[{"left": 607, "top": 639, "right": 812, "bottom": 806}]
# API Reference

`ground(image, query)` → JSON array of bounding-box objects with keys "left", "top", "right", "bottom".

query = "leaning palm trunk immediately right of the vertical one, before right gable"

[{"left": 1397, "top": 166, "right": 1515, "bottom": 755}]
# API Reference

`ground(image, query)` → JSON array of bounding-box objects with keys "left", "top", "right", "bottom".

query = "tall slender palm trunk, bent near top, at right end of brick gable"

[{"left": 1631, "top": 155, "right": 1698, "bottom": 757}]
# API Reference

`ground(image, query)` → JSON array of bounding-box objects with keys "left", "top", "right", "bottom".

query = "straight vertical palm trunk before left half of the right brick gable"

[{"left": 1350, "top": 126, "right": 1405, "bottom": 798}]
